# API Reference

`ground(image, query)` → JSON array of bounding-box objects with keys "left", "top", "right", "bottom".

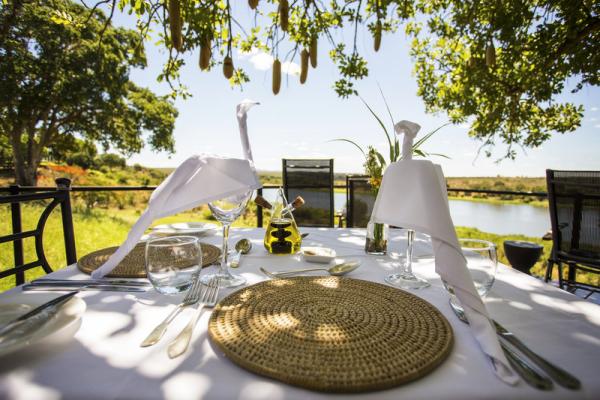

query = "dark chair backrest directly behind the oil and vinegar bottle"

[{"left": 282, "top": 159, "right": 335, "bottom": 227}]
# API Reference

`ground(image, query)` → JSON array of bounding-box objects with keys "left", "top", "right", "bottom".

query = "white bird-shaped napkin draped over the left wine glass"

[{"left": 92, "top": 100, "right": 261, "bottom": 278}]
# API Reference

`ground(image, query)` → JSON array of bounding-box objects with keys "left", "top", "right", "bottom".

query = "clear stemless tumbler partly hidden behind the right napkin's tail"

[{"left": 443, "top": 239, "right": 498, "bottom": 310}]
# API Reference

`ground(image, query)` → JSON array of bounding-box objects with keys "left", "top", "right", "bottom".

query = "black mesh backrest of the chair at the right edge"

[{"left": 546, "top": 169, "right": 600, "bottom": 265}]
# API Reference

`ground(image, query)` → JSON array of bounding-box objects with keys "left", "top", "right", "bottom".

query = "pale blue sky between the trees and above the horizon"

[{"left": 110, "top": 2, "right": 600, "bottom": 176}]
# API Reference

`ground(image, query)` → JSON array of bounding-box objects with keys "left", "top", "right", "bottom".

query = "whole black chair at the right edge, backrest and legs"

[{"left": 545, "top": 170, "right": 600, "bottom": 298}]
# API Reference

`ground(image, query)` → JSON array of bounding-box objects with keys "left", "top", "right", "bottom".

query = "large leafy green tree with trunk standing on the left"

[{"left": 0, "top": 0, "right": 177, "bottom": 185}]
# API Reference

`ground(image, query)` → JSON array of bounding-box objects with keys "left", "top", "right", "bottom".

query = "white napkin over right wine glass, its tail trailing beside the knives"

[{"left": 371, "top": 121, "right": 519, "bottom": 385}]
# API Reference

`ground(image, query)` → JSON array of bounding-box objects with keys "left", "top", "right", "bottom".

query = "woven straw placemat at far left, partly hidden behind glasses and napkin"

[{"left": 77, "top": 243, "right": 221, "bottom": 278}]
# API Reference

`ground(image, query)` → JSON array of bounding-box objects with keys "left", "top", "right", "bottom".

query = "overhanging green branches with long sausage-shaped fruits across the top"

[{"left": 70, "top": 0, "right": 600, "bottom": 157}]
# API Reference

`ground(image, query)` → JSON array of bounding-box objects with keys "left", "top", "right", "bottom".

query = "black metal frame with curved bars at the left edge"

[{"left": 0, "top": 178, "right": 77, "bottom": 285}]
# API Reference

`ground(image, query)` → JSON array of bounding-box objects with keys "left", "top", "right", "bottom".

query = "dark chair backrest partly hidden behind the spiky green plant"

[{"left": 346, "top": 175, "right": 377, "bottom": 228}]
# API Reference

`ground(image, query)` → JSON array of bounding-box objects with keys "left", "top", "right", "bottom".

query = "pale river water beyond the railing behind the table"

[{"left": 263, "top": 189, "right": 550, "bottom": 237}]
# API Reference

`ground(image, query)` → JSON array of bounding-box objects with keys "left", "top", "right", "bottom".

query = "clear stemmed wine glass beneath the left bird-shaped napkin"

[{"left": 201, "top": 190, "right": 253, "bottom": 287}]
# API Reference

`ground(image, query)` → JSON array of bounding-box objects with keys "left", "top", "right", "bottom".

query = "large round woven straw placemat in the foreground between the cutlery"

[{"left": 208, "top": 277, "right": 453, "bottom": 392}]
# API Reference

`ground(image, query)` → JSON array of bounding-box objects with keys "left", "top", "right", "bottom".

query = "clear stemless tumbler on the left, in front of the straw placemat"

[{"left": 145, "top": 236, "right": 202, "bottom": 294}]
